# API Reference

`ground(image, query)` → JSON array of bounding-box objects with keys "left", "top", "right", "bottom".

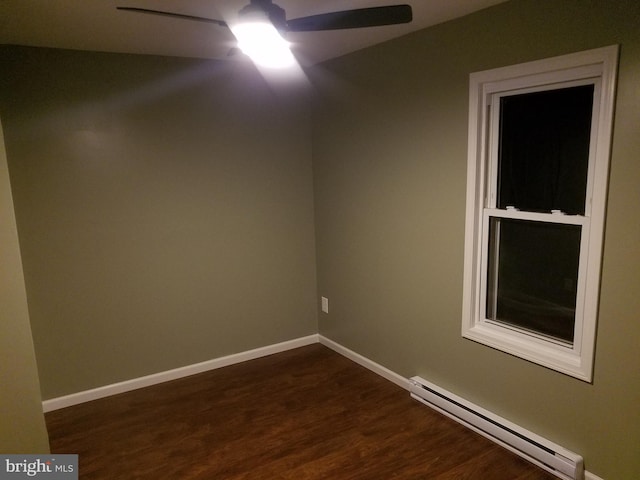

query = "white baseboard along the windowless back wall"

[{"left": 42, "top": 334, "right": 319, "bottom": 413}]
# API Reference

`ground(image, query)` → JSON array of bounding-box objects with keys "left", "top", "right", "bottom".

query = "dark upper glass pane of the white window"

[{"left": 498, "top": 85, "right": 594, "bottom": 215}]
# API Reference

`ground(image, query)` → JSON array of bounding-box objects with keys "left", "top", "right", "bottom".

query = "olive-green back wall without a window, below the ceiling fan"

[{"left": 0, "top": 47, "right": 317, "bottom": 399}]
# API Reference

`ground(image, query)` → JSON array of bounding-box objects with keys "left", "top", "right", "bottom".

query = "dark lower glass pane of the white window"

[{"left": 487, "top": 218, "right": 581, "bottom": 342}]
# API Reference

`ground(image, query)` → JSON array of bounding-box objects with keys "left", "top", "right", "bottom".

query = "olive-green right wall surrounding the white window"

[{"left": 313, "top": 0, "right": 640, "bottom": 480}]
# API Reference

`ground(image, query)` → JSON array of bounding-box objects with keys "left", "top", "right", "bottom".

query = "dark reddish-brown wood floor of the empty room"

[{"left": 46, "top": 344, "right": 556, "bottom": 480}]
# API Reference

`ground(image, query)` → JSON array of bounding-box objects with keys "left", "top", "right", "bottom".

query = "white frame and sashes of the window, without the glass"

[{"left": 462, "top": 45, "right": 618, "bottom": 382}]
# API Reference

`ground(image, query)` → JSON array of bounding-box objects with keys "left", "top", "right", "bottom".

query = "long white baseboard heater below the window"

[{"left": 409, "top": 377, "right": 584, "bottom": 480}]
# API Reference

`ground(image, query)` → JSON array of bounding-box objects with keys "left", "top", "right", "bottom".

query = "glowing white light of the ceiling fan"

[{"left": 231, "top": 20, "right": 295, "bottom": 68}]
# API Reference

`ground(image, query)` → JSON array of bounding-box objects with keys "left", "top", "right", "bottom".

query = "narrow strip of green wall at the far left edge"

[{"left": 0, "top": 117, "right": 49, "bottom": 453}]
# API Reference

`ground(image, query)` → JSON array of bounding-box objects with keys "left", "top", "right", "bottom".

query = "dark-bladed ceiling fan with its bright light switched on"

[{"left": 116, "top": 0, "right": 413, "bottom": 66}]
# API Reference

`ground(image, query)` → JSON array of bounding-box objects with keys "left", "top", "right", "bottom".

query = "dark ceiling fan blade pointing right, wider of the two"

[{"left": 287, "top": 5, "right": 413, "bottom": 32}]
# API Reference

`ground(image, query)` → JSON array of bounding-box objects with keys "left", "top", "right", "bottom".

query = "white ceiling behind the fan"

[{"left": 0, "top": 0, "right": 506, "bottom": 65}]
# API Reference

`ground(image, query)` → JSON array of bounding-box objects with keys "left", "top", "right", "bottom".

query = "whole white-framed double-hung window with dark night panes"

[{"left": 462, "top": 46, "right": 618, "bottom": 381}]
